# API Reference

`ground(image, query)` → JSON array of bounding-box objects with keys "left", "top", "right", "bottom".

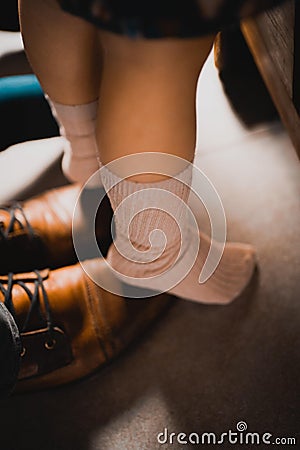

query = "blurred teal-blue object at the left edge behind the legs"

[{"left": 0, "top": 74, "right": 44, "bottom": 102}]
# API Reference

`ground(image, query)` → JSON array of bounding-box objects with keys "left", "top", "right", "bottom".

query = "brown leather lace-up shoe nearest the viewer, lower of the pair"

[{"left": 0, "top": 259, "right": 174, "bottom": 391}]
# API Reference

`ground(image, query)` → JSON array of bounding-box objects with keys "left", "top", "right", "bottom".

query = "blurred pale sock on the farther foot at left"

[{"left": 46, "top": 96, "right": 100, "bottom": 183}]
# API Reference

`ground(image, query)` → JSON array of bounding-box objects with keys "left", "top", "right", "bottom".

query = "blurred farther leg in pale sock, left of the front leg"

[{"left": 19, "top": 0, "right": 102, "bottom": 182}]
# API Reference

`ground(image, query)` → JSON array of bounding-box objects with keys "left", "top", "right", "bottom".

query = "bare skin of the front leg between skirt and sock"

[{"left": 98, "top": 32, "right": 213, "bottom": 177}]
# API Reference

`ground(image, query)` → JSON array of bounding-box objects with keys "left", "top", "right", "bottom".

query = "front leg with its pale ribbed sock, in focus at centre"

[{"left": 97, "top": 32, "right": 255, "bottom": 304}]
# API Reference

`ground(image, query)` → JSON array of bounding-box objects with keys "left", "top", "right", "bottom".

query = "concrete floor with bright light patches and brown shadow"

[{"left": 0, "top": 50, "right": 300, "bottom": 450}]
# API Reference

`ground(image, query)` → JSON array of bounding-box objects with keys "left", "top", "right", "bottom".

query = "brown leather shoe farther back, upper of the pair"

[{"left": 0, "top": 184, "right": 112, "bottom": 274}]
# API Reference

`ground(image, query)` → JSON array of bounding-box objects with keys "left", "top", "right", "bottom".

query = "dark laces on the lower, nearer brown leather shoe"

[{"left": 0, "top": 270, "right": 54, "bottom": 345}]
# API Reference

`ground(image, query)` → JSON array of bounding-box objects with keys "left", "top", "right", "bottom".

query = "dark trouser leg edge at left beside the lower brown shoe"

[{"left": 0, "top": 302, "right": 21, "bottom": 399}]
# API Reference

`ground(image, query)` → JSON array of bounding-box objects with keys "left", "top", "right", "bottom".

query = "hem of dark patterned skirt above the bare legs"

[{"left": 58, "top": 0, "right": 290, "bottom": 38}]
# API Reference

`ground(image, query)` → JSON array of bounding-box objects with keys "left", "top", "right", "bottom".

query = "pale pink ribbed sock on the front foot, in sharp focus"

[{"left": 102, "top": 165, "right": 255, "bottom": 304}]
